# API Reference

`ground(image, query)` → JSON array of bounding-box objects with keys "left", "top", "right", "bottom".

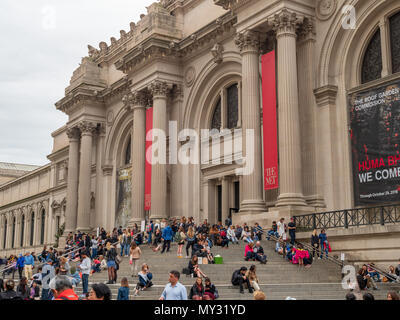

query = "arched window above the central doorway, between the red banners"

[{"left": 210, "top": 83, "right": 239, "bottom": 130}]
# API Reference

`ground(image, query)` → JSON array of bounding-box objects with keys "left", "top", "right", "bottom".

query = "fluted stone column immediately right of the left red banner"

[{"left": 149, "top": 80, "right": 168, "bottom": 219}]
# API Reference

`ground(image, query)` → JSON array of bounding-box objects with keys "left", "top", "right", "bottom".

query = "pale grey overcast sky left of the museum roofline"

[{"left": 0, "top": 0, "right": 156, "bottom": 165}]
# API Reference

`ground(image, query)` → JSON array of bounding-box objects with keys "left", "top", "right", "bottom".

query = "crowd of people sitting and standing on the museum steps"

[{"left": 0, "top": 217, "right": 400, "bottom": 300}]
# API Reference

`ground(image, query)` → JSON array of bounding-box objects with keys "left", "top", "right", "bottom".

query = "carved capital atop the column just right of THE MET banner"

[{"left": 268, "top": 8, "right": 304, "bottom": 38}]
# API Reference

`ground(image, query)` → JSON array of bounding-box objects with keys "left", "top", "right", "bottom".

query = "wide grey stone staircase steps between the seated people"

[{"left": 72, "top": 240, "right": 399, "bottom": 300}]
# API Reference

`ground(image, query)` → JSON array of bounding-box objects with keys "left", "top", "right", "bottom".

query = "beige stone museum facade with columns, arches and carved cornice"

[{"left": 0, "top": 0, "right": 400, "bottom": 258}]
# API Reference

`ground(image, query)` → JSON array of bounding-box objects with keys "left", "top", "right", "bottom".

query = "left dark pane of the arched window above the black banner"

[{"left": 361, "top": 28, "right": 382, "bottom": 83}]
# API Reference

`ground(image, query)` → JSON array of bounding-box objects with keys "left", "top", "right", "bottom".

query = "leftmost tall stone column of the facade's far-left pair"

[{"left": 64, "top": 127, "right": 80, "bottom": 235}]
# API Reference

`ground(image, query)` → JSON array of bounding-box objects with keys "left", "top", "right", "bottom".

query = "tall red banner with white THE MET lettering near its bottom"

[{"left": 261, "top": 51, "right": 279, "bottom": 190}]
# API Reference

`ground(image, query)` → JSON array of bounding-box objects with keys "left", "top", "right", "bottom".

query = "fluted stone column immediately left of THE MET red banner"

[{"left": 235, "top": 31, "right": 266, "bottom": 213}]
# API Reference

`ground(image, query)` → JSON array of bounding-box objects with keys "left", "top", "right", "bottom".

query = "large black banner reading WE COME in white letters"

[{"left": 349, "top": 80, "right": 400, "bottom": 206}]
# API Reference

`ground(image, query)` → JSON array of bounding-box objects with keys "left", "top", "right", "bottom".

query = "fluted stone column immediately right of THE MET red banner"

[{"left": 272, "top": 9, "right": 306, "bottom": 207}]
